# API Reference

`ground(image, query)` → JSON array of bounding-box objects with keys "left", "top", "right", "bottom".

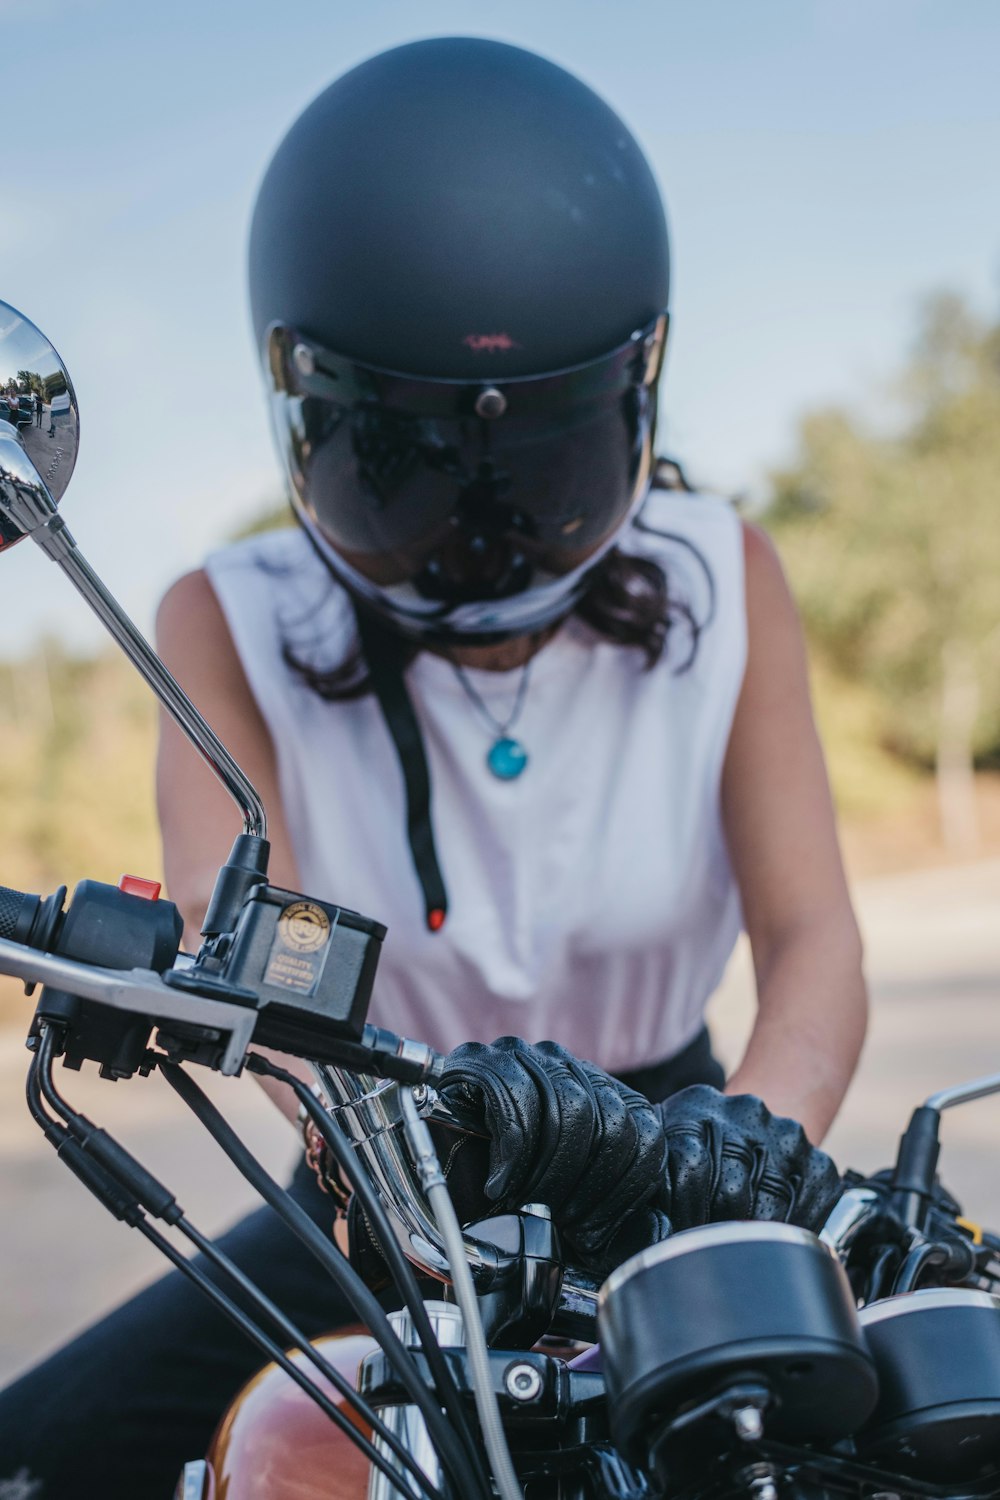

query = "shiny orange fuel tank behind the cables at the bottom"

[{"left": 202, "top": 1329, "right": 378, "bottom": 1500}]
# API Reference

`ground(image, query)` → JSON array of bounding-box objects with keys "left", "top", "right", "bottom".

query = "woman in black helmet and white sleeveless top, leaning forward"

[{"left": 0, "top": 39, "right": 865, "bottom": 1496}]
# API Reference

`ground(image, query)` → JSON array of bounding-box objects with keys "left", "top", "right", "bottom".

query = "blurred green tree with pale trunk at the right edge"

[{"left": 765, "top": 296, "right": 1000, "bottom": 849}]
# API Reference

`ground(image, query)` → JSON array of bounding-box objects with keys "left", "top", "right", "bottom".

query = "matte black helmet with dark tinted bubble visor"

[{"left": 250, "top": 38, "right": 669, "bottom": 642}]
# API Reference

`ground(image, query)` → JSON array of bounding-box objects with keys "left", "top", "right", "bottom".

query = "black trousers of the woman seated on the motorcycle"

[{"left": 0, "top": 1032, "right": 723, "bottom": 1500}]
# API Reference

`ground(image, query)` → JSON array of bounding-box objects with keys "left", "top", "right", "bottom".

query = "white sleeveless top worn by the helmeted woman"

[{"left": 207, "top": 491, "right": 747, "bottom": 1071}]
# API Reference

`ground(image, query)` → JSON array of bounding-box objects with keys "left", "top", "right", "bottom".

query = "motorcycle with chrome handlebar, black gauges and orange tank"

[{"left": 0, "top": 303, "right": 1000, "bottom": 1500}]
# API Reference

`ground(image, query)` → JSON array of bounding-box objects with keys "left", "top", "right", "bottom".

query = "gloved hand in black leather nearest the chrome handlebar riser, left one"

[{"left": 439, "top": 1037, "right": 670, "bottom": 1274}]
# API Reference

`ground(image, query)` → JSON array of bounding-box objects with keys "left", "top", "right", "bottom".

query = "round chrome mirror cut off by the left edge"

[{"left": 0, "top": 302, "right": 79, "bottom": 551}]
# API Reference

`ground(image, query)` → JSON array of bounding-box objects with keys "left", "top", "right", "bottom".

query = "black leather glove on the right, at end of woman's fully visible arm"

[{"left": 657, "top": 1083, "right": 843, "bottom": 1230}]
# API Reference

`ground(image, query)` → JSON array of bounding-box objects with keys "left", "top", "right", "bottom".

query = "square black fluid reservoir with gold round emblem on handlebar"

[{"left": 220, "top": 885, "right": 385, "bottom": 1061}]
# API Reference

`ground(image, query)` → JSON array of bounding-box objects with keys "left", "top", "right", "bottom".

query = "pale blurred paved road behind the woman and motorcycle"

[{"left": 0, "top": 860, "right": 1000, "bottom": 1380}]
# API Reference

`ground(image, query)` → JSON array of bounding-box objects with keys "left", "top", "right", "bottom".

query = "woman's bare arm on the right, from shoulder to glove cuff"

[{"left": 723, "top": 527, "right": 868, "bottom": 1142}]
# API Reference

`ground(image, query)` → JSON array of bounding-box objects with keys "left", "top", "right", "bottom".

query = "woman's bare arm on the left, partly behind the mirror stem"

[{"left": 156, "top": 572, "right": 310, "bottom": 1119}]
